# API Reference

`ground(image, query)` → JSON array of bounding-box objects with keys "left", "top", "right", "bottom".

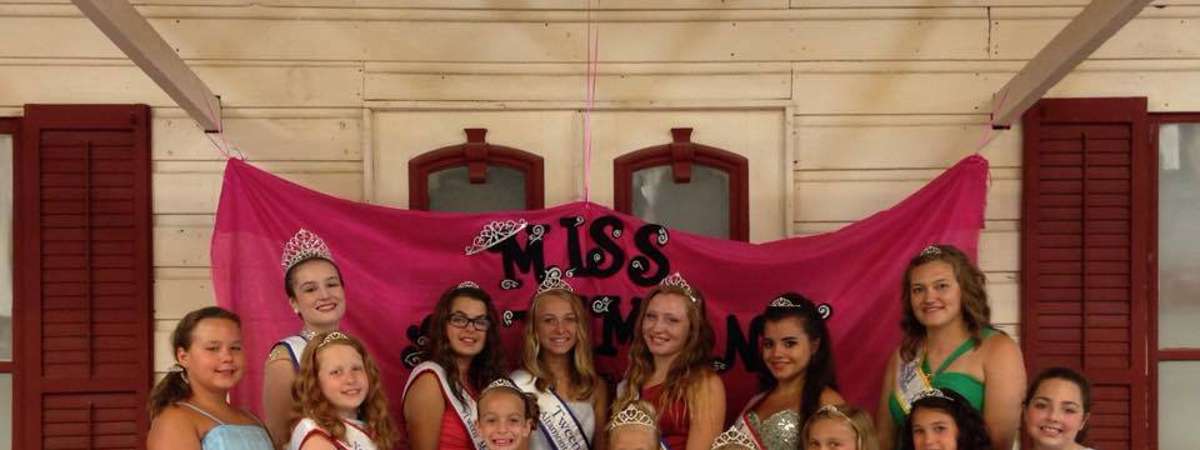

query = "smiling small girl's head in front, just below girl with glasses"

[{"left": 475, "top": 378, "right": 539, "bottom": 450}]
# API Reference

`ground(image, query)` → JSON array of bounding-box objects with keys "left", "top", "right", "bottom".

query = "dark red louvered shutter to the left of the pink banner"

[{"left": 14, "top": 106, "right": 154, "bottom": 449}]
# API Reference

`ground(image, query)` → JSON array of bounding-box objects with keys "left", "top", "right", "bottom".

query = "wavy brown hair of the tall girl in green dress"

[{"left": 900, "top": 244, "right": 991, "bottom": 361}]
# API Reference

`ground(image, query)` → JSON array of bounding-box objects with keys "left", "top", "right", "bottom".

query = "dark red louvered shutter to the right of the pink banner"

[{"left": 1021, "top": 98, "right": 1154, "bottom": 450}]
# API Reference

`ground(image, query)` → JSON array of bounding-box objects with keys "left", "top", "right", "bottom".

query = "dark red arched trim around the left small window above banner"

[{"left": 408, "top": 128, "right": 546, "bottom": 211}]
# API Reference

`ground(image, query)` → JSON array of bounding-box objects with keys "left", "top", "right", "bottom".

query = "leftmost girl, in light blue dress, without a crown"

[{"left": 146, "top": 306, "right": 274, "bottom": 450}]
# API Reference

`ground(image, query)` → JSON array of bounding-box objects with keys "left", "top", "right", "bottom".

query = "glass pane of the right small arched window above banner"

[{"left": 630, "top": 164, "right": 730, "bottom": 239}]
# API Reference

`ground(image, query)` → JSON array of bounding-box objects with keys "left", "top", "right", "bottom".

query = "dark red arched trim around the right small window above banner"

[{"left": 612, "top": 128, "right": 750, "bottom": 241}]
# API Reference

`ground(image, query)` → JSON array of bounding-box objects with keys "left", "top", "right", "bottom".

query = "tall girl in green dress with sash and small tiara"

[{"left": 877, "top": 245, "right": 1025, "bottom": 450}]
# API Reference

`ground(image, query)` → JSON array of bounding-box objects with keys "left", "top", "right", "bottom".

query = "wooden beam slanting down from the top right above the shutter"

[{"left": 991, "top": 0, "right": 1152, "bottom": 128}]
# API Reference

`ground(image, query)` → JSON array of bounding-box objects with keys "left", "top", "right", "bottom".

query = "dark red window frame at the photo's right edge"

[{"left": 1144, "top": 112, "right": 1200, "bottom": 449}]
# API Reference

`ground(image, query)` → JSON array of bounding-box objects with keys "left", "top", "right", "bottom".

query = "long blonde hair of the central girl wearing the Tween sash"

[{"left": 522, "top": 289, "right": 599, "bottom": 400}]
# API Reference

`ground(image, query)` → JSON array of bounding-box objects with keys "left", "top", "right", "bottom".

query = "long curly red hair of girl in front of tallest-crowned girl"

[{"left": 289, "top": 331, "right": 396, "bottom": 449}]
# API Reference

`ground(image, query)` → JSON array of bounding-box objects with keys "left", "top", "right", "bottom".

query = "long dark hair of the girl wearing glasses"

[{"left": 428, "top": 286, "right": 508, "bottom": 401}]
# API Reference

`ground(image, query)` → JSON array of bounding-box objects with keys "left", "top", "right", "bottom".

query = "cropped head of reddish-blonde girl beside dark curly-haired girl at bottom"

[{"left": 800, "top": 404, "right": 880, "bottom": 450}]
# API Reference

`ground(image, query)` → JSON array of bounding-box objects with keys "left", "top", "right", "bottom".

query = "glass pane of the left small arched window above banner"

[{"left": 428, "top": 166, "right": 526, "bottom": 212}]
